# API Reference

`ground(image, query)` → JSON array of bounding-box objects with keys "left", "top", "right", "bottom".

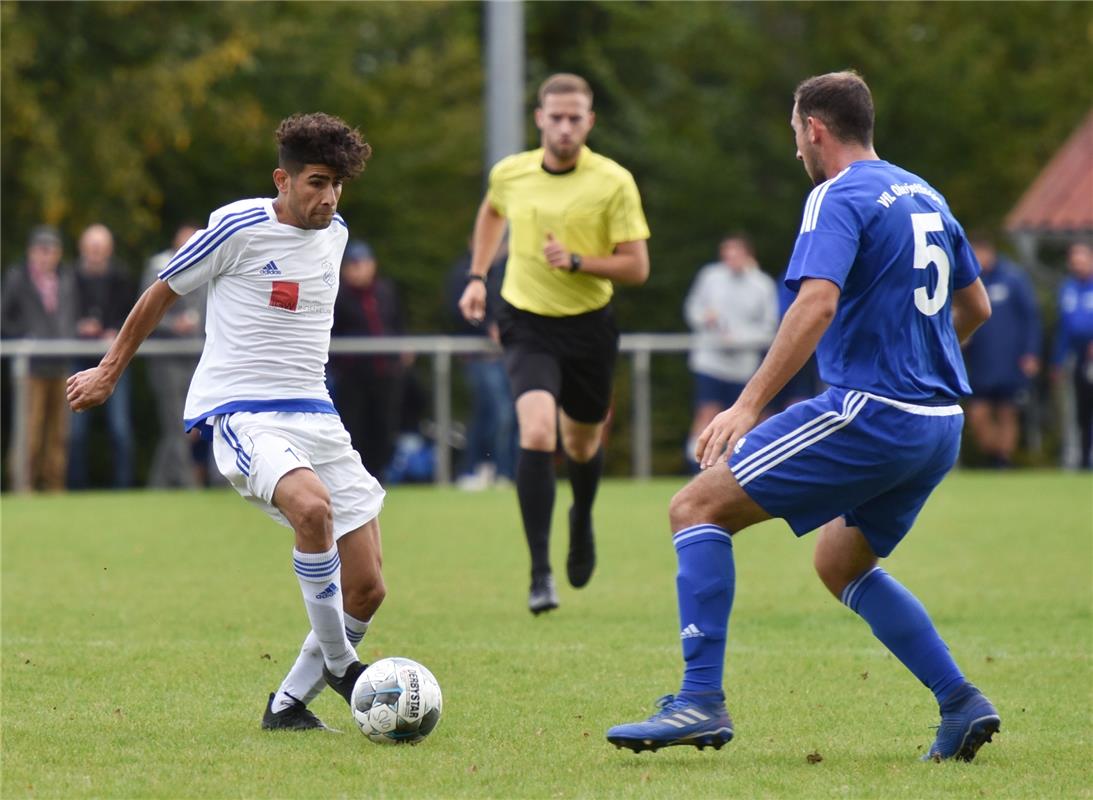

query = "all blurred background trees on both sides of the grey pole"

[{"left": 0, "top": 1, "right": 1093, "bottom": 474}]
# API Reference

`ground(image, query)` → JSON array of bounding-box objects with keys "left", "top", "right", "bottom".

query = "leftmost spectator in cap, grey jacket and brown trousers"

[{"left": 0, "top": 225, "right": 75, "bottom": 492}]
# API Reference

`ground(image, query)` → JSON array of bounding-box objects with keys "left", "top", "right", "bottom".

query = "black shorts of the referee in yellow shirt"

[{"left": 497, "top": 301, "right": 619, "bottom": 424}]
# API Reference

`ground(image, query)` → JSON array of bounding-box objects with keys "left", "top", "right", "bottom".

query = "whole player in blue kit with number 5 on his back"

[{"left": 607, "top": 72, "right": 1000, "bottom": 761}]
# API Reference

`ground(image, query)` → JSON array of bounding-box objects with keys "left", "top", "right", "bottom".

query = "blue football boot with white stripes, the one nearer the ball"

[{"left": 608, "top": 693, "right": 732, "bottom": 753}]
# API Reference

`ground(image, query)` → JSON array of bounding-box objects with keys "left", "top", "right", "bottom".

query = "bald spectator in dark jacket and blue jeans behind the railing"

[{"left": 68, "top": 224, "right": 134, "bottom": 489}]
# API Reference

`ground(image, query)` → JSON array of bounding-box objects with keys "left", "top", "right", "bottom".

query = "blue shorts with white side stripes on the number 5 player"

[{"left": 729, "top": 388, "right": 964, "bottom": 557}]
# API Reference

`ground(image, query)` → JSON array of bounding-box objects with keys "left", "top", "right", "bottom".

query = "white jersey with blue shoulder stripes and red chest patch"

[{"left": 158, "top": 199, "right": 349, "bottom": 430}]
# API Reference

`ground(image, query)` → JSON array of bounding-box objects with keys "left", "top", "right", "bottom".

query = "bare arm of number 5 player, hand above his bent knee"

[{"left": 694, "top": 279, "right": 841, "bottom": 469}]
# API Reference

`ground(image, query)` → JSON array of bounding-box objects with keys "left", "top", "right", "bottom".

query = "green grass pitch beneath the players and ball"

[{"left": 0, "top": 472, "right": 1093, "bottom": 800}]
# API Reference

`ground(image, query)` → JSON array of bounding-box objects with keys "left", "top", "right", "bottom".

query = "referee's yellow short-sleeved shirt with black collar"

[{"left": 486, "top": 148, "right": 649, "bottom": 317}]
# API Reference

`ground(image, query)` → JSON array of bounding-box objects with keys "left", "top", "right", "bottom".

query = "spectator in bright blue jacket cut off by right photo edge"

[{"left": 1051, "top": 242, "right": 1093, "bottom": 470}]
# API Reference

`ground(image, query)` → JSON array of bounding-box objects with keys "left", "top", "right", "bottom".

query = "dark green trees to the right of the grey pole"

[{"left": 529, "top": 2, "right": 1093, "bottom": 330}]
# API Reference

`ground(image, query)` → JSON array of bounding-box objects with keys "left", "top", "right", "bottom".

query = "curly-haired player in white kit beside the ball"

[{"left": 68, "top": 114, "right": 385, "bottom": 730}]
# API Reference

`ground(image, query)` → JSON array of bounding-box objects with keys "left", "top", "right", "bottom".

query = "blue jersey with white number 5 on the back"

[{"left": 786, "top": 161, "right": 979, "bottom": 404}]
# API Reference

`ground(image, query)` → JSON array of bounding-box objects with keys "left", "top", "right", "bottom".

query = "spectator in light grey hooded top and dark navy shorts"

[{"left": 683, "top": 234, "right": 778, "bottom": 471}]
